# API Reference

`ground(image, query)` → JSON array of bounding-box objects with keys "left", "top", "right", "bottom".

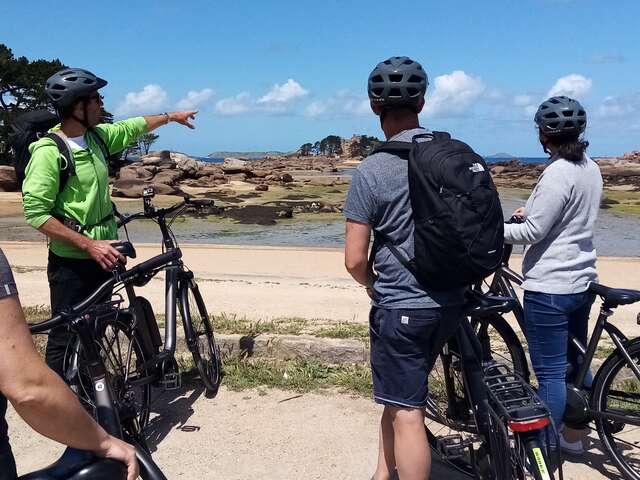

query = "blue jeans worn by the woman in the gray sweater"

[{"left": 524, "top": 291, "right": 595, "bottom": 438}]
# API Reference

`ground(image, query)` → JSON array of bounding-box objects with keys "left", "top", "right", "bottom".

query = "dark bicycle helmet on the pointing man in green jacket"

[{"left": 44, "top": 68, "right": 107, "bottom": 108}]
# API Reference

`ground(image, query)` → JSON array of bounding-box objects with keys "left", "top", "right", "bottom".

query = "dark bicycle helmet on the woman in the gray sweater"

[{"left": 535, "top": 97, "right": 587, "bottom": 137}]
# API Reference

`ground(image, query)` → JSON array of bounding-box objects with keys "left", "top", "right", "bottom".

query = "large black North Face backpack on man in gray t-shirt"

[{"left": 374, "top": 132, "right": 504, "bottom": 291}]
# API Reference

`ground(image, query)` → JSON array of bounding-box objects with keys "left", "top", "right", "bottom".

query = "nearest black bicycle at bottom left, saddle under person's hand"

[{"left": 20, "top": 250, "right": 175, "bottom": 480}]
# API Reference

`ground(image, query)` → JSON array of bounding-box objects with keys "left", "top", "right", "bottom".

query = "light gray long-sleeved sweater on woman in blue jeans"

[{"left": 504, "top": 155, "right": 602, "bottom": 294}]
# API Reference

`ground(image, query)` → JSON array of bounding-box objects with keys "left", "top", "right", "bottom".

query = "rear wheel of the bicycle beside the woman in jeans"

[{"left": 591, "top": 338, "right": 640, "bottom": 480}]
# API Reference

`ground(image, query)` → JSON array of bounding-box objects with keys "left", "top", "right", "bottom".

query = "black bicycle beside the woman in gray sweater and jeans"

[{"left": 464, "top": 218, "right": 640, "bottom": 480}]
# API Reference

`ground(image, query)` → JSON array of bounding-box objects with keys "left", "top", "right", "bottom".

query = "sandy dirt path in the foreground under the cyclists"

[{"left": 8, "top": 381, "right": 619, "bottom": 480}]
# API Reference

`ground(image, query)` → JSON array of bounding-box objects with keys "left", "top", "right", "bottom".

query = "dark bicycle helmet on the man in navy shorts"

[{"left": 367, "top": 57, "right": 429, "bottom": 108}]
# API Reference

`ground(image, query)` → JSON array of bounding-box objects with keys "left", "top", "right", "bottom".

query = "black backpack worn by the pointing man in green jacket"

[{"left": 9, "top": 110, "right": 109, "bottom": 192}]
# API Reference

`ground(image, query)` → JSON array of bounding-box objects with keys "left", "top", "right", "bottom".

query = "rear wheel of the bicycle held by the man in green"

[{"left": 75, "top": 317, "right": 153, "bottom": 443}]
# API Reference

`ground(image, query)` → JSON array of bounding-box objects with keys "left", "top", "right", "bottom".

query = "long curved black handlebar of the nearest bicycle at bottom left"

[{"left": 29, "top": 248, "right": 182, "bottom": 334}]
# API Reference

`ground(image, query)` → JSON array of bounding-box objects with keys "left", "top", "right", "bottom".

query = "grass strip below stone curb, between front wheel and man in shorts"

[{"left": 223, "top": 358, "right": 372, "bottom": 396}]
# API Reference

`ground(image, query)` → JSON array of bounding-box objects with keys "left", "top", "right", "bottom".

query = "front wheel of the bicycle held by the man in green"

[{"left": 179, "top": 279, "right": 222, "bottom": 397}]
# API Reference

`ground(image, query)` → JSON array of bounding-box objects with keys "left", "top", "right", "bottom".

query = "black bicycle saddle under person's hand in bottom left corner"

[{"left": 18, "top": 448, "right": 127, "bottom": 480}]
